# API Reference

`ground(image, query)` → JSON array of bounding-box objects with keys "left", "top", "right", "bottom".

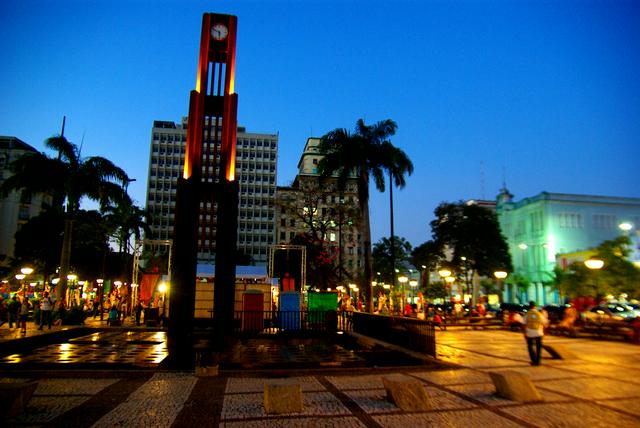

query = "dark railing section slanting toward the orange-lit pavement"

[{"left": 353, "top": 312, "right": 436, "bottom": 358}]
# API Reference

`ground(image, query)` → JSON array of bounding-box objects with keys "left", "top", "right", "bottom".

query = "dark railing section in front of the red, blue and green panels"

[{"left": 228, "top": 311, "right": 351, "bottom": 335}]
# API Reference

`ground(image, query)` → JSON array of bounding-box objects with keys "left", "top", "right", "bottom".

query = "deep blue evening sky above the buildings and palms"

[{"left": 0, "top": 0, "right": 640, "bottom": 246}]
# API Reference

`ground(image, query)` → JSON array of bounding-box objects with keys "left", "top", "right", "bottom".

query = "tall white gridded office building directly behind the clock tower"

[{"left": 146, "top": 118, "right": 278, "bottom": 265}]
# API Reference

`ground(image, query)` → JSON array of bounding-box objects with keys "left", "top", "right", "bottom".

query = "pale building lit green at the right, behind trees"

[{"left": 497, "top": 189, "right": 640, "bottom": 304}]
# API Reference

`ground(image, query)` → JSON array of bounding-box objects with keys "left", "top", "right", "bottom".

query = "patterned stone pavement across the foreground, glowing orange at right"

[{"left": 0, "top": 320, "right": 640, "bottom": 427}]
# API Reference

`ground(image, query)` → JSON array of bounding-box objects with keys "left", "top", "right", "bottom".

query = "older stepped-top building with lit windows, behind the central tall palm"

[{"left": 276, "top": 138, "right": 364, "bottom": 286}]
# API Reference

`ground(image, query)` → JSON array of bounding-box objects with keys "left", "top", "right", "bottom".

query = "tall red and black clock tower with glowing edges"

[{"left": 169, "top": 13, "right": 238, "bottom": 361}]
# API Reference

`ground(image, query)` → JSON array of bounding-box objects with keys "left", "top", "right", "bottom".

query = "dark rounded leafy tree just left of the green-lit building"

[{"left": 431, "top": 202, "right": 513, "bottom": 304}]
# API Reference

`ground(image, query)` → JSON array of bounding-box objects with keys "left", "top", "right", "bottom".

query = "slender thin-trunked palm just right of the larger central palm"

[{"left": 381, "top": 140, "right": 413, "bottom": 286}]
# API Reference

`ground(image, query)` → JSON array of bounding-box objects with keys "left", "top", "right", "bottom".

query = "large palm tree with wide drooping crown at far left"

[{"left": 0, "top": 136, "right": 130, "bottom": 306}]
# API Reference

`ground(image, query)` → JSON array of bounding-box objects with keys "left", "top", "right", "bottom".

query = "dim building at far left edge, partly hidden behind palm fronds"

[{"left": 0, "top": 136, "right": 51, "bottom": 266}]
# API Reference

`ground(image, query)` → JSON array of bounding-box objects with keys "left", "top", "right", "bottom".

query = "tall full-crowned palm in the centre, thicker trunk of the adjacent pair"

[{"left": 318, "top": 119, "right": 397, "bottom": 312}]
